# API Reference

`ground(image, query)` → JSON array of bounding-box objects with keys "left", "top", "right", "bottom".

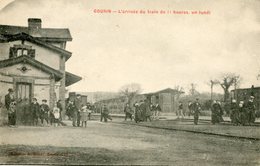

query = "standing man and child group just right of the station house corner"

[{"left": 66, "top": 94, "right": 92, "bottom": 127}]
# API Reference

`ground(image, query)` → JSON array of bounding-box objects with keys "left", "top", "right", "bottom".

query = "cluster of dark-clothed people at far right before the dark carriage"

[{"left": 230, "top": 96, "right": 256, "bottom": 126}]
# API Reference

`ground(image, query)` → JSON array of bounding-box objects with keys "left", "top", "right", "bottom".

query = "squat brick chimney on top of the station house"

[{"left": 28, "top": 18, "right": 42, "bottom": 37}]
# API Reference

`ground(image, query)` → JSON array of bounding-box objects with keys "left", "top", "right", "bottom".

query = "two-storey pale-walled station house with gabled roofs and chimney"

[{"left": 0, "top": 18, "right": 81, "bottom": 123}]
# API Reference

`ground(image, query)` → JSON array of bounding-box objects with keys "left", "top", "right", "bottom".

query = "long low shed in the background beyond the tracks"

[{"left": 95, "top": 88, "right": 184, "bottom": 113}]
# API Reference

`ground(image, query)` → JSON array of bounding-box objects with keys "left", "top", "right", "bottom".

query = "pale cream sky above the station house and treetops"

[{"left": 0, "top": 0, "right": 260, "bottom": 92}]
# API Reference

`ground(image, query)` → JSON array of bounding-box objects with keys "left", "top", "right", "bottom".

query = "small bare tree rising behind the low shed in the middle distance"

[{"left": 119, "top": 83, "right": 142, "bottom": 103}]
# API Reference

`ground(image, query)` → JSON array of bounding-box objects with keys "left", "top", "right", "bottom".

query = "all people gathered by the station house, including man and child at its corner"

[{"left": 5, "top": 88, "right": 91, "bottom": 127}]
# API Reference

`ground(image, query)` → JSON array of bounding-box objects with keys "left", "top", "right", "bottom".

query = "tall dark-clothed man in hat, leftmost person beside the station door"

[{"left": 5, "top": 88, "right": 16, "bottom": 125}]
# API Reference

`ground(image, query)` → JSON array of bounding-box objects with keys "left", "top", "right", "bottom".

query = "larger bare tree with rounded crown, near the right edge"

[{"left": 218, "top": 73, "right": 240, "bottom": 102}]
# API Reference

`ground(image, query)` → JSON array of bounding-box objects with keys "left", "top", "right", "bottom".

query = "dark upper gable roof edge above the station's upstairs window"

[{"left": 3, "top": 32, "right": 72, "bottom": 60}]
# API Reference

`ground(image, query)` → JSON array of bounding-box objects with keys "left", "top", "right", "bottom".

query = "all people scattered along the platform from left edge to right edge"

[{"left": 2, "top": 88, "right": 256, "bottom": 127}]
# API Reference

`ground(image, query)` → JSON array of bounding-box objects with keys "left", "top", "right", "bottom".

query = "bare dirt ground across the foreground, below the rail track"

[{"left": 0, "top": 121, "right": 260, "bottom": 165}]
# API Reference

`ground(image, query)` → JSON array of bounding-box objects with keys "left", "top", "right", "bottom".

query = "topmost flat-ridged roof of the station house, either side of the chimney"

[{"left": 0, "top": 25, "right": 72, "bottom": 41}]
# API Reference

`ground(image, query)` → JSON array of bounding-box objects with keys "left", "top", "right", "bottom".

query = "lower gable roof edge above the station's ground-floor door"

[{"left": 0, "top": 55, "right": 63, "bottom": 81}]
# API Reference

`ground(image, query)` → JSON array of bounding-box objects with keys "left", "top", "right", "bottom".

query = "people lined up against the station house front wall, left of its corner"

[{"left": 5, "top": 88, "right": 62, "bottom": 126}]
